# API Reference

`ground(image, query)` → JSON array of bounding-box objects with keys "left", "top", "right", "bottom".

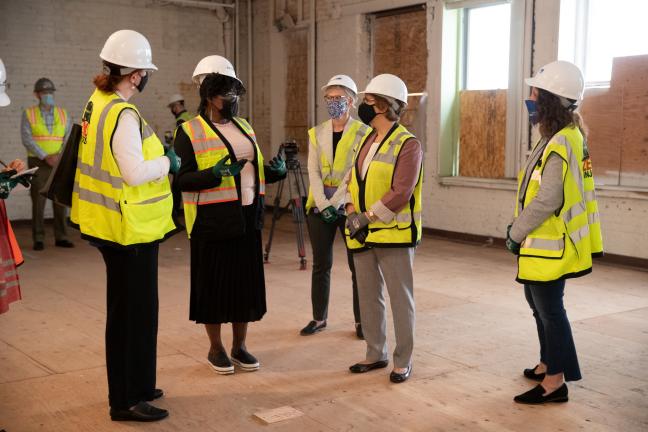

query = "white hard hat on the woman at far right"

[{"left": 524, "top": 60, "right": 585, "bottom": 101}]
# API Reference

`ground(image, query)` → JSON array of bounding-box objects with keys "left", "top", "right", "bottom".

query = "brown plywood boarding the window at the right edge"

[{"left": 581, "top": 55, "right": 648, "bottom": 188}]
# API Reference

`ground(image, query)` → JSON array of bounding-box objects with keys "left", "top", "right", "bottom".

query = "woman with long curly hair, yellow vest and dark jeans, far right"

[{"left": 506, "top": 61, "right": 603, "bottom": 404}]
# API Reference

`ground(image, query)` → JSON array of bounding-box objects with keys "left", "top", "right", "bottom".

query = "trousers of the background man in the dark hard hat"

[{"left": 27, "top": 157, "right": 67, "bottom": 242}]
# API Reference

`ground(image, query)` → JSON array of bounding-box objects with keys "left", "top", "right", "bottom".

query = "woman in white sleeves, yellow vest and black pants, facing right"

[{"left": 71, "top": 30, "right": 180, "bottom": 421}]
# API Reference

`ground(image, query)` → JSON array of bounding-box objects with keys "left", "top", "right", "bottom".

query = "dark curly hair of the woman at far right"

[{"left": 536, "top": 88, "right": 587, "bottom": 139}]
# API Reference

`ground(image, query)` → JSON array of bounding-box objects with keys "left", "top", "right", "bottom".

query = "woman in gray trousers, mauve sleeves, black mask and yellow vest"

[{"left": 346, "top": 74, "right": 423, "bottom": 383}]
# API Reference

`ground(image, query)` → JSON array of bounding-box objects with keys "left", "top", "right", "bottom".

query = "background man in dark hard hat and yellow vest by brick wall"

[{"left": 20, "top": 78, "right": 74, "bottom": 250}]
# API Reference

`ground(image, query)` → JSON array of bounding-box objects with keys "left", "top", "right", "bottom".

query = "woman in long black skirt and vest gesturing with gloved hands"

[{"left": 174, "top": 55, "right": 286, "bottom": 375}]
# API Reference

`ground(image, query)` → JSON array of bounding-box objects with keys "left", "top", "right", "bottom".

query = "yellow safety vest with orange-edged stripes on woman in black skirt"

[{"left": 180, "top": 115, "right": 265, "bottom": 238}]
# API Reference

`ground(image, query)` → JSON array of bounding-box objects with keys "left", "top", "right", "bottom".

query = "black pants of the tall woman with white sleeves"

[{"left": 99, "top": 243, "right": 158, "bottom": 409}]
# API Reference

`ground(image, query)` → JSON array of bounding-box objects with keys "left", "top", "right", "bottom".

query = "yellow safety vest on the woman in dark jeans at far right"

[{"left": 515, "top": 126, "right": 603, "bottom": 284}]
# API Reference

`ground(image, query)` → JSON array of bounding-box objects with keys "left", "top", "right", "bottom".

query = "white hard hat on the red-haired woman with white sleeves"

[{"left": 99, "top": 30, "right": 157, "bottom": 70}]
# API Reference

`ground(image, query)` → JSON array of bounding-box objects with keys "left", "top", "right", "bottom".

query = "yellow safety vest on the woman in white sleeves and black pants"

[{"left": 70, "top": 90, "right": 176, "bottom": 246}]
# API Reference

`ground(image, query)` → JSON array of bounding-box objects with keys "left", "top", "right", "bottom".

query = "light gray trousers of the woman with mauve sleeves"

[{"left": 353, "top": 247, "right": 415, "bottom": 368}]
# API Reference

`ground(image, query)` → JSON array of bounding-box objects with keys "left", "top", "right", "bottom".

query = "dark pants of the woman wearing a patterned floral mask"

[{"left": 308, "top": 212, "right": 360, "bottom": 323}]
